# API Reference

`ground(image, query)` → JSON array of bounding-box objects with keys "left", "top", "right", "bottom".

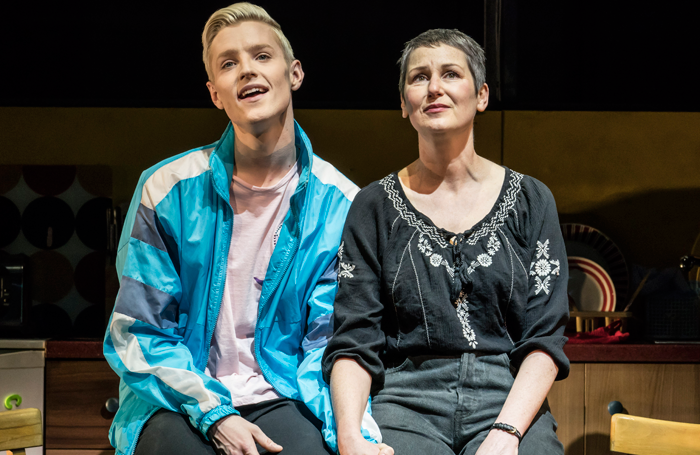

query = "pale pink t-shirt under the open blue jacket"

[{"left": 207, "top": 165, "right": 299, "bottom": 406}]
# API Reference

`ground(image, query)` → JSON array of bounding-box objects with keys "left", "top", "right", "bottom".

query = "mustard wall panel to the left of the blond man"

[{"left": 0, "top": 108, "right": 228, "bottom": 203}]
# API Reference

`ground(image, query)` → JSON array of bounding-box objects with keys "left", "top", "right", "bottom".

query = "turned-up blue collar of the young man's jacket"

[{"left": 209, "top": 120, "right": 313, "bottom": 201}]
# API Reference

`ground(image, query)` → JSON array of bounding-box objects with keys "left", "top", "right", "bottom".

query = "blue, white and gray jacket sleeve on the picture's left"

[{"left": 104, "top": 171, "right": 237, "bottom": 437}]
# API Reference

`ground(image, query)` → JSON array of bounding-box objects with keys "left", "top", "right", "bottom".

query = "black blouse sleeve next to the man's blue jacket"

[{"left": 323, "top": 188, "right": 386, "bottom": 391}]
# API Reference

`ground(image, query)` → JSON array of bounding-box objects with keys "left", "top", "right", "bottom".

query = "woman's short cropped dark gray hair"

[{"left": 397, "top": 28, "right": 486, "bottom": 97}]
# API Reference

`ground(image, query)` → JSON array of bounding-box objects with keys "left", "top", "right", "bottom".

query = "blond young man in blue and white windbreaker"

[{"left": 104, "top": 3, "right": 383, "bottom": 455}]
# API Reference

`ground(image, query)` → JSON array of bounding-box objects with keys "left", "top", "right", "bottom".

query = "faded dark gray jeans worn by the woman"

[{"left": 372, "top": 354, "right": 564, "bottom": 455}]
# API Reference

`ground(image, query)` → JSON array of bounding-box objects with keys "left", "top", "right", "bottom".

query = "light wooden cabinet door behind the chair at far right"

[{"left": 585, "top": 363, "right": 700, "bottom": 455}]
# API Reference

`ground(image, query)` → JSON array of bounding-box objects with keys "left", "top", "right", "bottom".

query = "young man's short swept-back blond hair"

[{"left": 202, "top": 2, "right": 294, "bottom": 81}]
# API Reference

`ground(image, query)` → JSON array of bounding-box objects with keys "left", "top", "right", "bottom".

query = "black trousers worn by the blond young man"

[{"left": 135, "top": 398, "right": 333, "bottom": 455}]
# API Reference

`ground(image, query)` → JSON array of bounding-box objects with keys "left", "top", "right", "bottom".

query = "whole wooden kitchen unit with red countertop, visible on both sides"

[{"left": 5, "top": 341, "right": 700, "bottom": 455}]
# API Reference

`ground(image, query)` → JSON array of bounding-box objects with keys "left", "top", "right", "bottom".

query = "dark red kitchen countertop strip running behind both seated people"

[{"left": 46, "top": 340, "right": 700, "bottom": 363}]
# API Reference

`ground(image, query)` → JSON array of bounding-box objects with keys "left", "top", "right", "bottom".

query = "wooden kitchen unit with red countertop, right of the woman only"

[{"left": 548, "top": 344, "right": 700, "bottom": 455}]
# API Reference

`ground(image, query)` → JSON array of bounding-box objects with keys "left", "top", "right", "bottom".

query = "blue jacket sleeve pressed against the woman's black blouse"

[{"left": 297, "top": 194, "right": 382, "bottom": 452}]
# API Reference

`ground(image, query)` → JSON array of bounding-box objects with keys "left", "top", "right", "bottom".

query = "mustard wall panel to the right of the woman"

[{"left": 503, "top": 111, "right": 700, "bottom": 266}]
